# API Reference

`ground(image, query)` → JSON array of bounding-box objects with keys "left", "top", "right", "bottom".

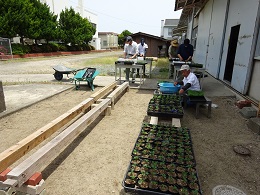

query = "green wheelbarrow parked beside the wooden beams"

[{"left": 73, "top": 68, "right": 99, "bottom": 91}]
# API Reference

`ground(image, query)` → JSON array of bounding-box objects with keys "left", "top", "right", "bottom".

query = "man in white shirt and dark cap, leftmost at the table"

[{"left": 124, "top": 36, "right": 138, "bottom": 83}]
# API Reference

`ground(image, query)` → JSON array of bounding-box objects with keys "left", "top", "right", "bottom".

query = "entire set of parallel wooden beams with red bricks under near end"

[{"left": 0, "top": 82, "right": 129, "bottom": 195}]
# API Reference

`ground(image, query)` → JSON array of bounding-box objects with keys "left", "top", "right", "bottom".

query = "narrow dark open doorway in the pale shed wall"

[{"left": 224, "top": 25, "right": 240, "bottom": 82}]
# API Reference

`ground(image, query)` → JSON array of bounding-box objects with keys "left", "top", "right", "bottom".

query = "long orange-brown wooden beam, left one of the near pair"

[{"left": 0, "top": 98, "right": 94, "bottom": 173}]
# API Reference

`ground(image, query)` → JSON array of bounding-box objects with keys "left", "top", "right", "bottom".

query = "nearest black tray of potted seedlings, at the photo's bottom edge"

[{"left": 122, "top": 157, "right": 202, "bottom": 195}]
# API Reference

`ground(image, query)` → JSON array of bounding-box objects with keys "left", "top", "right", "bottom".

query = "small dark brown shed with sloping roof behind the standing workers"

[{"left": 131, "top": 32, "right": 167, "bottom": 57}]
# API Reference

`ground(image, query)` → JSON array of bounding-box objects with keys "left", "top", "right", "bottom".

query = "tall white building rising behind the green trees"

[{"left": 41, "top": 0, "right": 101, "bottom": 50}]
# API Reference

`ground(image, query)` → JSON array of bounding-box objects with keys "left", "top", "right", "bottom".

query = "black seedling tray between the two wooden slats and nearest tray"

[{"left": 132, "top": 123, "right": 196, "bottom": 166}]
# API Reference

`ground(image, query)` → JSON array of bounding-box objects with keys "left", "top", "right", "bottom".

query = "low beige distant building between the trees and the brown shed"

[{"left": 98, "top": 32, "right": 118, "bottom": 49}]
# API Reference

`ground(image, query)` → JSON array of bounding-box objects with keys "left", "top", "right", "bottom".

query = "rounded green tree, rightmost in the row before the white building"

[{"left": 59, "top": 7, "right": 96, "bottom": 45}]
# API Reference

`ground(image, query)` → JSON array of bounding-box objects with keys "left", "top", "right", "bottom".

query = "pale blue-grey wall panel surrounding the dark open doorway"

[{"left": 220, "top": 0, "right": 259, "bottom": 93}]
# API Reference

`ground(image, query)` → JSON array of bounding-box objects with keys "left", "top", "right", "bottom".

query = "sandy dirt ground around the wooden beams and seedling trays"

[{"left": 0, "top": 88, "right": 260, "bottom": 195}]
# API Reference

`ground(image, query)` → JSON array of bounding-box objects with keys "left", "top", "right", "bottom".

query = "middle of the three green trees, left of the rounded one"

[{"left": 28, "top": 0, "right": 58, "bottom": 42}]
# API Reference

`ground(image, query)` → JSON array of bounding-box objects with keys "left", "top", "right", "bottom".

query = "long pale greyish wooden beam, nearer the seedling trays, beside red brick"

[{"left": 3, "top": 99, "right": 111, "bottom": 187}]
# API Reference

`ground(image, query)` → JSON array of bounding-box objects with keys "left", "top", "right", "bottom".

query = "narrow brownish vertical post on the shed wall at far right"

[{"left": 243, "top": 3, "right": 260, "bottom": 94}]
